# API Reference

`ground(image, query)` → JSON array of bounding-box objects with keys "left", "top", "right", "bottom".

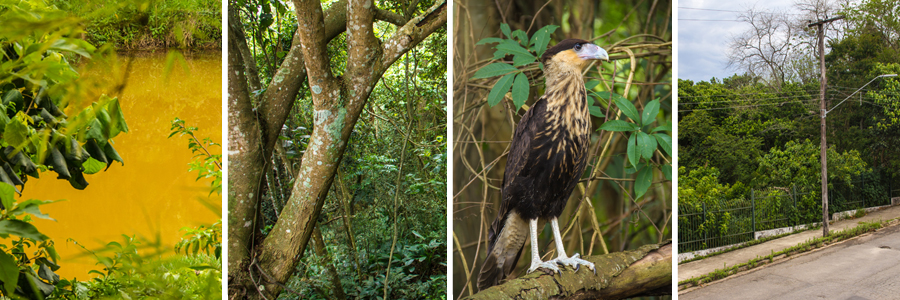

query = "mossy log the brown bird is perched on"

[{"left": 466, "top": 240, "right": 672, "bottom": 300}]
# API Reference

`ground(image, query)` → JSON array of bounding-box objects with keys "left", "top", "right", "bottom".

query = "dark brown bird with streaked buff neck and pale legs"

[{"left": 478, "top": 39, "right": 609, "bottom": 290}]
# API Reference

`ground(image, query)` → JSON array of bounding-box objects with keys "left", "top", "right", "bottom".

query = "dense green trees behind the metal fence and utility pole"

[{"left": 678, "top": 0, "right": 900, "bottom": 250}]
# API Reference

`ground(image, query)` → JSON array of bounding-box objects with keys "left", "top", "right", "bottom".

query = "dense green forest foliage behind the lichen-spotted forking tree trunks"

[{"left": 234, "top": 0, "right": 447, "bottom": 299}]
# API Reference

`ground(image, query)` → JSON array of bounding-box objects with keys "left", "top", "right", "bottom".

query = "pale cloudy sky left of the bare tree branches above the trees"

[{"left": 676, "top": 0, "right": 794, "bottom": 82}]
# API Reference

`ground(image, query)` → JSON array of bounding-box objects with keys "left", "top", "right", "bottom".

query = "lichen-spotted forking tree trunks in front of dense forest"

[{"left": 229, "top": 0, "right": 447, "bottom": 299}]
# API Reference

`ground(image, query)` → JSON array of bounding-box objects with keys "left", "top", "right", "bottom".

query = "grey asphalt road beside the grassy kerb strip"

[{"left": 678, "top": 224, "right": 900, "bottom": 300}]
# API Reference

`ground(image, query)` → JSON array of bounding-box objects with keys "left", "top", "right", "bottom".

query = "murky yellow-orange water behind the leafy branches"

[{"left": 20, "top": 52, "right": 222, "bottom": 280}]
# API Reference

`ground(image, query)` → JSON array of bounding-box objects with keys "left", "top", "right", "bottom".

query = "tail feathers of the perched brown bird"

[{"left": 478, "top": 212, "right": 528, "bottom": 291}]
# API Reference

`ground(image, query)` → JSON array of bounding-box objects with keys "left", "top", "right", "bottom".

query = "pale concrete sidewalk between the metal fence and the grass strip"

[{"left": 678, "top": 206, "right": 900, "bottom": 281}]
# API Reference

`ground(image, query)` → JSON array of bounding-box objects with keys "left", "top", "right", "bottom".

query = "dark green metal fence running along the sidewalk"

[{"left": 678, "top": 171, "right": 900, "bottom": 253}]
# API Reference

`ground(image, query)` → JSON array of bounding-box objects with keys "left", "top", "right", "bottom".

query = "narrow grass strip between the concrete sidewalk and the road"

[{"left": 678, "top": 220, "right": 892, "bottom": 290}]
